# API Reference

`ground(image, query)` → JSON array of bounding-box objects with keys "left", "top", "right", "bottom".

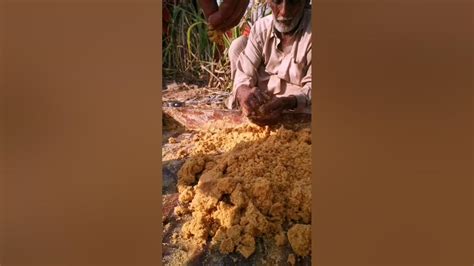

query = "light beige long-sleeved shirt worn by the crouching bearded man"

[{"left": 226, "top": 9, "right": 311, "bottom": 112}]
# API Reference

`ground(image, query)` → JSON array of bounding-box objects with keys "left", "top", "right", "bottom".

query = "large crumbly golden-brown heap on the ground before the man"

[{"left": 175, "top": 125, "right": 311, "bottom": 260}]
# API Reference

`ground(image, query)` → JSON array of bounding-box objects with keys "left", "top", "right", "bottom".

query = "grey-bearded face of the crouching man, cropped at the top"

[{"left": 267, "top": 0, "right": 307, "bottom": 33}]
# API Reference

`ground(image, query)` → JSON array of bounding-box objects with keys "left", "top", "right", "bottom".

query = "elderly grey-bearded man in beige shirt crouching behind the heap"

[{"left": 227, "top": 0, "right": 312, "bottom": 124}]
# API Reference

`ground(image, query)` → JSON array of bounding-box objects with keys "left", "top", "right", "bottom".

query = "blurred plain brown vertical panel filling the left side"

[{"left": 1, "top": 1, "right": 161, "bottom": 266}]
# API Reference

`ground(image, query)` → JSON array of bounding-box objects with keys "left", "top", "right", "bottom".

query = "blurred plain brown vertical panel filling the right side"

[{"left": 313, "top": 0, "right": 474, "bottom": 266}]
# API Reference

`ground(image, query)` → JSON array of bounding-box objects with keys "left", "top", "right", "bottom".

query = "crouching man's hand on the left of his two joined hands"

[{"left": 236, "top": 85, "right": 270, "bottom": 116}]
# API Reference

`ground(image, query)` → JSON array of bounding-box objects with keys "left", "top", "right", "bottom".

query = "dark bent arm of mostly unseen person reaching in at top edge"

[{"left": 199, "top": 0, "right": 249, "bottom": 32}]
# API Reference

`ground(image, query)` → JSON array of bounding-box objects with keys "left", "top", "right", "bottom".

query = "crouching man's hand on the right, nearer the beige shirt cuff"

[{"left": 249, "top": 95, "right": 297, "bottom": 125}]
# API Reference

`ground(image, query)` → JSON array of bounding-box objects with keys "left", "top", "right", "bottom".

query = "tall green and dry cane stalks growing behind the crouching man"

[{"left": 163, "top": 1, "right": 240, "bottom": 91}]
